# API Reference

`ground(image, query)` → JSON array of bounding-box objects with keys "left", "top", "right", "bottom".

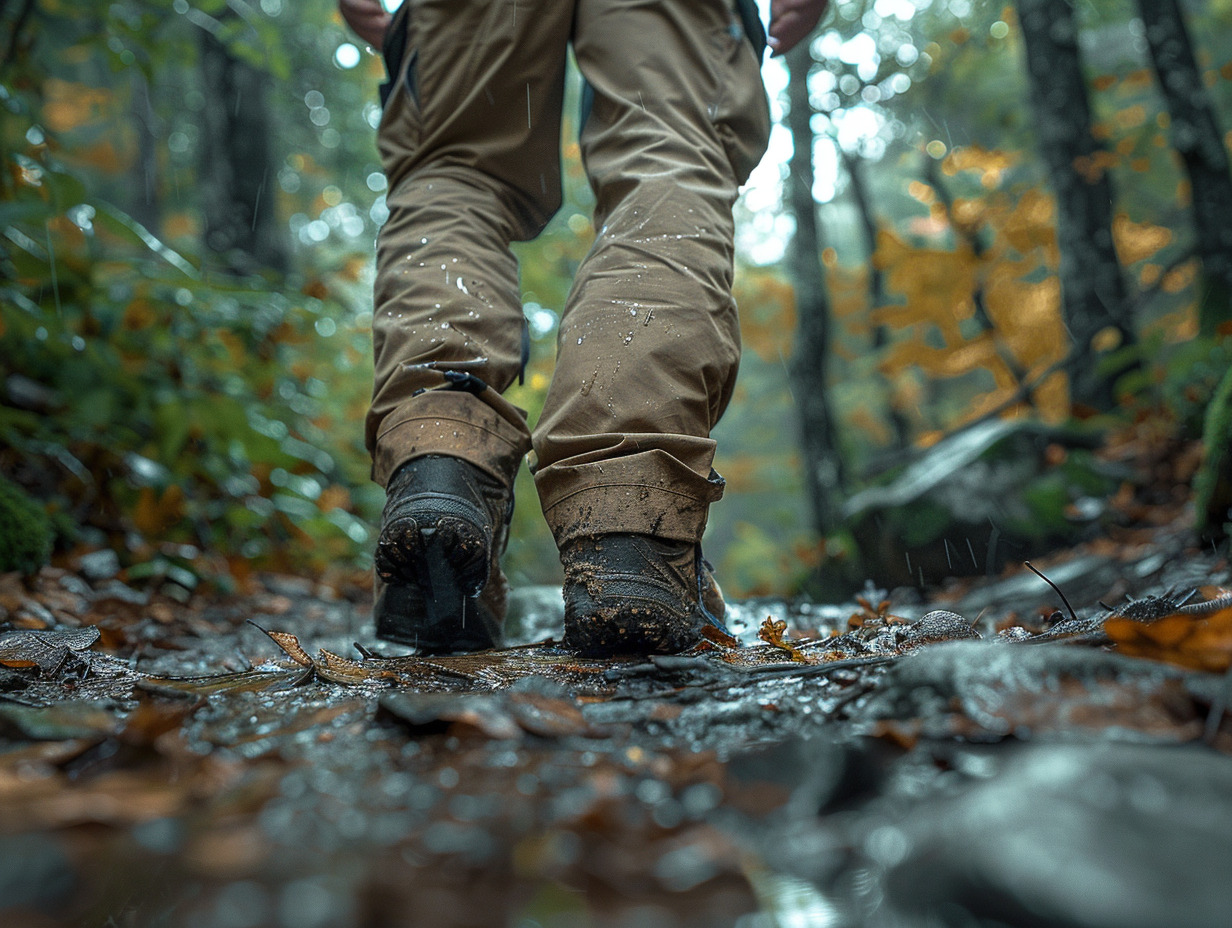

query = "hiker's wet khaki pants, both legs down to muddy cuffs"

[{"left": 366, "top": 0, "right": 770, "bottom": 545}]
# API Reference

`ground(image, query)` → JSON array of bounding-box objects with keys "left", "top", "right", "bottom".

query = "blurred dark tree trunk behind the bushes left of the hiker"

[{"left": 201, "top": 21, "right": 286, "bottom": 274}]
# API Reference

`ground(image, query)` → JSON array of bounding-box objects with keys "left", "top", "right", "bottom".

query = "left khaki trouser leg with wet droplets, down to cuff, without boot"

[{"left": 365, "top": 0, "right": 573, "bottom": 484}]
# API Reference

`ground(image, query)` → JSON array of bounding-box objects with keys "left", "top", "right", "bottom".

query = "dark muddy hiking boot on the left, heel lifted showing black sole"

[{"left": 373, "top": 455, "right": 514, "bottom": 653}]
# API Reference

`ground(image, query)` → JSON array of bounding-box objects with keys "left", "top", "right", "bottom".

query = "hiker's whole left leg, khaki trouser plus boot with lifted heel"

[{"left": 366, "top": 0, "right": 572, "bottom": 651}]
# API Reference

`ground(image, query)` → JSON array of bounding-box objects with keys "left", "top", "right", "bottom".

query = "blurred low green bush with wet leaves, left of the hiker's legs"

[{"left": 0, "top": 155, "right": 367, "bottom": 569}]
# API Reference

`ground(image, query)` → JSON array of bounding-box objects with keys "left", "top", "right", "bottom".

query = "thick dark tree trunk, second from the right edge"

[{"left": 1018, "top": 0, "right": 1133, "bottom": 409}]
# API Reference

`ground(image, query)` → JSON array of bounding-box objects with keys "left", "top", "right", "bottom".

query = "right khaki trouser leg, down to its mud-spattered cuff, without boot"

[{"left": 533, "top": 0, "right": 770, "bottom": 545}]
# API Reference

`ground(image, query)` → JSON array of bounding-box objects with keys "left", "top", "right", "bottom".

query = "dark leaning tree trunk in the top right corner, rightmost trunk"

[{"left": 1138, "top": 0, "right": 1232, "bottom": 335}]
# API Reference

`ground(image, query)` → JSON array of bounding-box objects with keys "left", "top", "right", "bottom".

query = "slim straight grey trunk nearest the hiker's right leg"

[{"left": 787, "top": 42, "right": 843, "bottom": 535}]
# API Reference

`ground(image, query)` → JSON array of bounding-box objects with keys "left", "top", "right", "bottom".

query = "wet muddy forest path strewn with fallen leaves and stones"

[{"left": 0, "top": 517, "right": 1232, "bottom": 928}]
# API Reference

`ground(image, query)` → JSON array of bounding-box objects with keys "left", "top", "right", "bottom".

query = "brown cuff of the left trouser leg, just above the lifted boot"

[{"left": 372, "top": 387, "right": 531, "bottom": 487}]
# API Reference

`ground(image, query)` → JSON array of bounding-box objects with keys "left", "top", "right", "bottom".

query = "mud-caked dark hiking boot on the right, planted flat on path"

[{"left": 561, "top": 534, "right": 723, "bottom": 657}]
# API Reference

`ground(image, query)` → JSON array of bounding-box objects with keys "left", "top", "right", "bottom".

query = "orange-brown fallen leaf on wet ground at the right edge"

[{"left": 1104, "top": 606, "right": 1232, "bottom": 673}]
